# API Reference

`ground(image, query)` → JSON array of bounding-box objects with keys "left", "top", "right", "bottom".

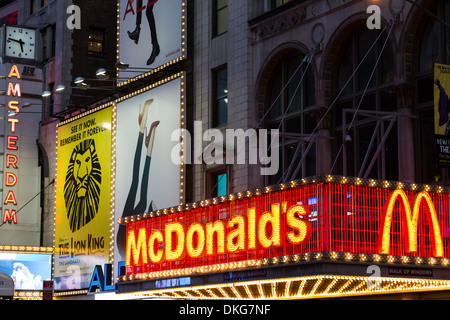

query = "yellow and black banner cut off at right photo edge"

[{"left": 434, "top": 64, "right": 450, "bottom": 167}]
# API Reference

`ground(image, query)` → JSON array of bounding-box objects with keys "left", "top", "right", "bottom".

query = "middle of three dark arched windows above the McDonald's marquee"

[{"left": 332, "top": 27, "right": 398, "bottom": 180}]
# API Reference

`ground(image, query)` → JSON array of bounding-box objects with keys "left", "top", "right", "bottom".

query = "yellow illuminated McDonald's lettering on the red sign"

[{"left": 126, "top": 202, "right": 311, "bottom": 265}]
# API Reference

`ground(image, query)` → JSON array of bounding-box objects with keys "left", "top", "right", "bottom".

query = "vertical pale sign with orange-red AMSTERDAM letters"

[{"left": 0, "top": 63, "right": 42, "bottom": 245}]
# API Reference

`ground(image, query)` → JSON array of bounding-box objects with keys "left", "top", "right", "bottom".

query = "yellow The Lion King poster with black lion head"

[{"left": 54, "top": 107, "right": 112, "bottom": 290}]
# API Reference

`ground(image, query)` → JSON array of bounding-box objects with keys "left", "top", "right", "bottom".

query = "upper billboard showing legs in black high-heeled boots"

[{"left": 117, "top": 0, "right": 186, "bottom": 85}]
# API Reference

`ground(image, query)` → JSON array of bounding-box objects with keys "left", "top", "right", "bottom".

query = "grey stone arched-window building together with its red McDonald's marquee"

[{"left": 110, "top": 0, "right": 450, "bottom": 299}]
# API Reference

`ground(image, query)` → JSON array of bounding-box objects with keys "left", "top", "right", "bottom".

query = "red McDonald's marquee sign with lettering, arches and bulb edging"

[{"left": 119, "top": 176, "right": 450, "bottom": 281}]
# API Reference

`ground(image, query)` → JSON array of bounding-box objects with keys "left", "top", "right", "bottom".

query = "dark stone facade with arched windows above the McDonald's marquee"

[{"left": 194, "top": 1, "right": 447, "bottom": 200}]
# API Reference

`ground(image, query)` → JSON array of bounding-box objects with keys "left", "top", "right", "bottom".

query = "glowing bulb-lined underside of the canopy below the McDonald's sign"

[{"left": 119, "top": 275, "right": 450, "bottom": 300}]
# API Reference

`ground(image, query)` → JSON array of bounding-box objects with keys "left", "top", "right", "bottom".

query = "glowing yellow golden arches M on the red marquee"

[{"left": 379, "top": 190, "right": 444, "bottom": 257}]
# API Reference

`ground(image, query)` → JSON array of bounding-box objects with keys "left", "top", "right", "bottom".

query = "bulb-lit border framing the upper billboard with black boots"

[{"left": 116, "top": 0, "right": 187, "bottom": 87}]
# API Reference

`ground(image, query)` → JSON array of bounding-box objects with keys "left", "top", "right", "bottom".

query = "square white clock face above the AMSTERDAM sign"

[{"left": 5, "top": 26, "right": 36, "bottom": 59}]
